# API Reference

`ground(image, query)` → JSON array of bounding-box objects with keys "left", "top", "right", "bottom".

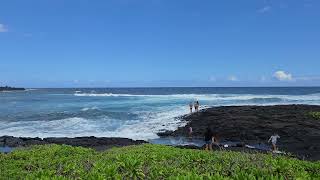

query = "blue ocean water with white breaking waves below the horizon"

[{"left": 0, "top": 87, "right": 320, "bottom": 140}]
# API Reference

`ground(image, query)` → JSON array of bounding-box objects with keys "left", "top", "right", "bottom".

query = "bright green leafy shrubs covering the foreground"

[{"left": 0, "top": 144, "right": 320, "bottom": 180}]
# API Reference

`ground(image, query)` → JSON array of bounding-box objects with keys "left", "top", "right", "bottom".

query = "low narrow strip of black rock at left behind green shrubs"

[{"left": 0, "top": 136, "right": 148, "bottom": 151}]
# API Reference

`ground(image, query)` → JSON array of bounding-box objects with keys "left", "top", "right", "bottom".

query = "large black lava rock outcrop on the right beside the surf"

[{"left": 158, "top": 105, "right": 320, "bottom": 160}]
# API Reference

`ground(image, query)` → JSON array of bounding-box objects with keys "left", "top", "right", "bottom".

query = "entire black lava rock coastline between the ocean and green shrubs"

[{"left": 0, "top": 105, "right": 320, "bottom": 161}]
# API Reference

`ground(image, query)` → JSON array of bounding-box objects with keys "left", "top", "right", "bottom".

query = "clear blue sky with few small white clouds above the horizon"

[{"left": 0, "top": 0, "right": 320, "bottom": 87}]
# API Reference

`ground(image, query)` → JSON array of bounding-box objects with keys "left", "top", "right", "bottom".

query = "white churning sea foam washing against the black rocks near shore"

[{"left": 0, "top": 107, "right": 187, "bottom": 140}]
